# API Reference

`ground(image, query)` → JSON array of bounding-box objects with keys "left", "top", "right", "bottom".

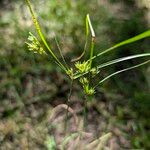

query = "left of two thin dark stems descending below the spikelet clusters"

[{"left": 65, "top": 80, "right": 73, "bottom": 131}]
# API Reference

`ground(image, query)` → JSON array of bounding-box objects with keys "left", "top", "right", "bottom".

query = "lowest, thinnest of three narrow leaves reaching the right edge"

[{"left": 94, "top": 60, "right": 150, "bottom": 88}]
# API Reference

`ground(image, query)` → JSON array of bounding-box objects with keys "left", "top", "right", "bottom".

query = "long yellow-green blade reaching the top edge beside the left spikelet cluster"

[{"left": 25, "top": 0, "right": 66, "bottom": 71}]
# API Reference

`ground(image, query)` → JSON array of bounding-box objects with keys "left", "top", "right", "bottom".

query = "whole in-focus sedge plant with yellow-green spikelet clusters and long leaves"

[{"left": 25, "top": 0, "right": 150, "bottom": 129}]
